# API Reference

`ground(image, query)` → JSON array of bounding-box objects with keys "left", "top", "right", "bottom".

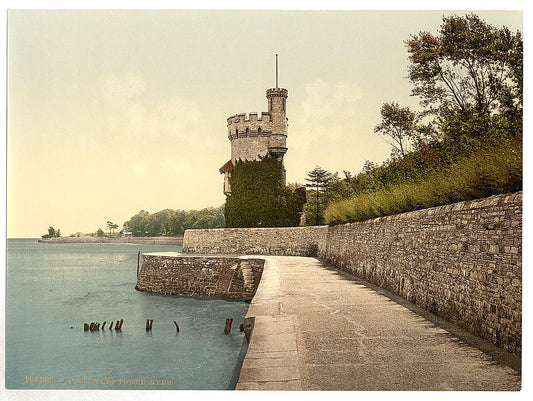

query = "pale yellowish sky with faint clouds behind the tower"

[{"left": 6, "top": 10, "right": 522, "bottom": 238}]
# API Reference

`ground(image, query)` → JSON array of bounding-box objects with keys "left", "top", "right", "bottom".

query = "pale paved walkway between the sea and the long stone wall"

[{"left": 236, "top": 256, "right": 520, "bottom": 391}]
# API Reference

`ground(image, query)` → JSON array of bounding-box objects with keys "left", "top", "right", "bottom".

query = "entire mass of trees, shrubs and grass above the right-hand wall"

[{"left": 314, "top": 14, "right": 523, "bottom": 224}]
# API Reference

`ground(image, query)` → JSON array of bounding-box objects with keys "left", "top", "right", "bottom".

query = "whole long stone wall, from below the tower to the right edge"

[{"left": 183, "top": 192, "right": 522, "bottom": 355}]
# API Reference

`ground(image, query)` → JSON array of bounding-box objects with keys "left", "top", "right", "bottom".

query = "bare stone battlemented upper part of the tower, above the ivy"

[{"left": 220, "top": 88, "right": 288, "bottom": 194}]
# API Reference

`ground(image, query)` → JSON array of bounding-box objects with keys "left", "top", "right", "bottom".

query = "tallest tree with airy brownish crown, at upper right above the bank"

[{"left": 405, "top": 14, "right": 522, "bottom": 140}]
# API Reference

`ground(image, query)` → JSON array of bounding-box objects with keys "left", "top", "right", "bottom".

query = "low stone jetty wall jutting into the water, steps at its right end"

[{"left": 135, "top": 253, "right": 264, "bottom": 301}]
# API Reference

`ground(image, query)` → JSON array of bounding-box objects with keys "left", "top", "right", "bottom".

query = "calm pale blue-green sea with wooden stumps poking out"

[{"left": 6, "top": 239, "right": 248, "bottom": 390}]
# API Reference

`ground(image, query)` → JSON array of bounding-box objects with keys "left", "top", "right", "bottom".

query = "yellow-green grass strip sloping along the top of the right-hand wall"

[{"left": 325, "top": 140, "right": 522, "bottom": 224}]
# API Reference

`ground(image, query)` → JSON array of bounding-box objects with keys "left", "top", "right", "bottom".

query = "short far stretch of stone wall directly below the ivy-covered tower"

[{"left": 183, "top": 226, "right": 328, "bottom": 256}]
